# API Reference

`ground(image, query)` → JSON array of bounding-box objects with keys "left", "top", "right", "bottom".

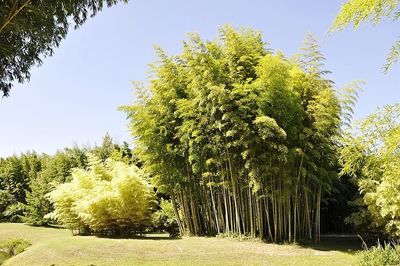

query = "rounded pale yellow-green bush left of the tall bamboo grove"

[{"left": 46, "top": 157, "right": 155, "bottom": 235}]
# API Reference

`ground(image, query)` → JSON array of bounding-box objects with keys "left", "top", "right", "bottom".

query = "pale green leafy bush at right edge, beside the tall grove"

[{"left": 340, "top": 104, "right": 400, "bottom": 237}]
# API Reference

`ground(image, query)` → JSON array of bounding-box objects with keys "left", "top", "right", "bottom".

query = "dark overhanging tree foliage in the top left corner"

[{"left": 0, "top": 0, "right": 128, "bottom": 96}]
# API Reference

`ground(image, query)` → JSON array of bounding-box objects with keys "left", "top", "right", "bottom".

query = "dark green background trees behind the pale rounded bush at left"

[{"left": 0, "top": 134, "right": 134, "bottom": 225}]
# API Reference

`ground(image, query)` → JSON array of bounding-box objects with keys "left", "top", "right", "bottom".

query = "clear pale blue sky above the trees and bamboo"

[{"left": 0, "top": 0, "right": 400, "bottom": 156}]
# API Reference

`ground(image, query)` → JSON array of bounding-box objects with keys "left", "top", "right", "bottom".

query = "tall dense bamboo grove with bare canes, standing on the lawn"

[{"left": 121, "top": 26, "right": 342, "bottom": 242}]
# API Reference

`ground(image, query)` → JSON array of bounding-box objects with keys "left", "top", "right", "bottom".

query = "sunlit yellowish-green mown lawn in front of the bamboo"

[{"left": 0, "top": 223, "right": 357, "bottom": 266}]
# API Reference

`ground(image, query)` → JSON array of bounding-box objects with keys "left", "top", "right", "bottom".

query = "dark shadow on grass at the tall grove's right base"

[{"left": 299, "top": 234, "right": 362, "bottom": 254}]
